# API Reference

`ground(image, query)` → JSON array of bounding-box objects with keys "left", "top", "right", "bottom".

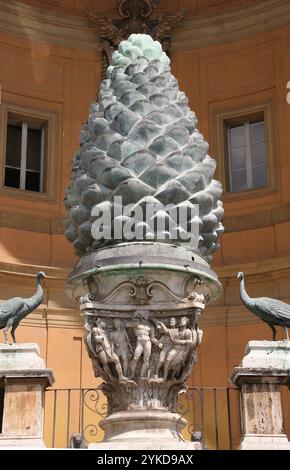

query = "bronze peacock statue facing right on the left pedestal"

[{"left": 0, "top": 271, "right": 46, "bottom": 343}]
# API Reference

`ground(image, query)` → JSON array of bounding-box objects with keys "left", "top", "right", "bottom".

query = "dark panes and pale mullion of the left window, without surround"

[{"left": 4, "top": 113, "right": 47, "bottom": 192}]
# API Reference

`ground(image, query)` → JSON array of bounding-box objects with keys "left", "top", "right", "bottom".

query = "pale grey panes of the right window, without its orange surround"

[{"left": 226, "top": 115, "right": 268, "bottom": 192}]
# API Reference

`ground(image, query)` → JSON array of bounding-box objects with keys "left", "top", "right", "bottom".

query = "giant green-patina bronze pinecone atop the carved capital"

[{"left": 64, "top": 34, "right": 224, "bottom": 261}]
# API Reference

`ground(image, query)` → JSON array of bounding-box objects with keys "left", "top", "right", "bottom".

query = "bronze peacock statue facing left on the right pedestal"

[{"left": 237, "top": 272, "right": 290, "bottom": 341}]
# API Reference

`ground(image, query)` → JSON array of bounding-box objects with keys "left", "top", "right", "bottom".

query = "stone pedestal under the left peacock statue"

[{"left": 0, "top": 343, "right": 54, "bottom": 447}]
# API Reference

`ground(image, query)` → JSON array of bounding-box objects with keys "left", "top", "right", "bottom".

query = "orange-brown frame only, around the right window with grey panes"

[{"left": 213, "top": 100, "right": 279, "bottom": 201}]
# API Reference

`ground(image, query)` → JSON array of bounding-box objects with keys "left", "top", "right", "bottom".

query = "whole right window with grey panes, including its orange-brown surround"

[{"left": 210, "top": 99, "right": 280, "bottom": 204}]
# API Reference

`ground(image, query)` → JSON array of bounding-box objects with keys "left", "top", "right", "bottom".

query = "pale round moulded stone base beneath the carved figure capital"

[{"left": 89, "top": 410, "right": 200, "bottom": 450}]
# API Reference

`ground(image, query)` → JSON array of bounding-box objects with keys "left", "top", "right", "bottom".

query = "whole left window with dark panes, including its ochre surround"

[{"left": 0, "top": 101, "right": 62, "bottom": 201}]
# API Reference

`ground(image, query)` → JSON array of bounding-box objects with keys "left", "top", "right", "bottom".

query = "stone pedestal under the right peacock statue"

[{"left": 230, "top": 341, "right": 290, "bottom": 450}]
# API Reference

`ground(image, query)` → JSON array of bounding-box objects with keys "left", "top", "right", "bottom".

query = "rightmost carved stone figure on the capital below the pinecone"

[{"left": 163, "top": 317, "right": 193, "bottom": 380}]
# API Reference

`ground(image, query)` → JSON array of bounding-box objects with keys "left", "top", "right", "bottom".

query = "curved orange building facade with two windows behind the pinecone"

[{"left": 0, "top": 0, "right": 290, "bottom": 445}]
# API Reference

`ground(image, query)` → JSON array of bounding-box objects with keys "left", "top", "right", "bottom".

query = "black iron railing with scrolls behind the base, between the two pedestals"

[{"left": 44, "top": 387, "right": 241, "bottom": 450}]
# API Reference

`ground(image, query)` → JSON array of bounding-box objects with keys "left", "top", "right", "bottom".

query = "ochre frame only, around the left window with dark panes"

[{"left": 0, "top": 102, "right": 59, "bottom": 201}]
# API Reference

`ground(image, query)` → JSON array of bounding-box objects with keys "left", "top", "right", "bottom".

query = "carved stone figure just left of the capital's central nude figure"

[{"left": 110, "top": 318, "right": 133, "bottom": 376}]
